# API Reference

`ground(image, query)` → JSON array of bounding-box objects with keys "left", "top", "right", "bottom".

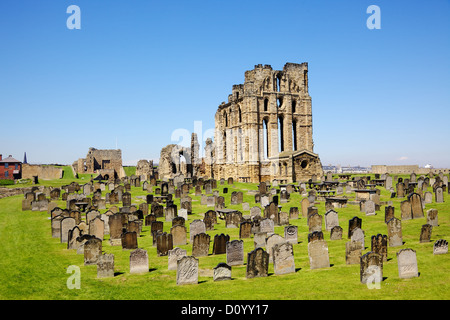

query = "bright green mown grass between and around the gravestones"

[{"left": 0, "top": 169, "right": 450, "bottom": 300}]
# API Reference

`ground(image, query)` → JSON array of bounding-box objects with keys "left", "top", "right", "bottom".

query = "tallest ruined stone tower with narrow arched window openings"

[{"left": 212, "top": 63, "right": 323, "bottom": 183}]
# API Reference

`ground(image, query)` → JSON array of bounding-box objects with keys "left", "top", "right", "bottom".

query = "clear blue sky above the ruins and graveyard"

[{"left": 0, "top": 0, "right": 450, "bottom": 168}]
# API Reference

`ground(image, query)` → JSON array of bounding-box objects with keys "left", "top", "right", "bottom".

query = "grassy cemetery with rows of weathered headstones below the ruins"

[{"left": 0, "top": 167, "right": 450, "bottom": 300}]
